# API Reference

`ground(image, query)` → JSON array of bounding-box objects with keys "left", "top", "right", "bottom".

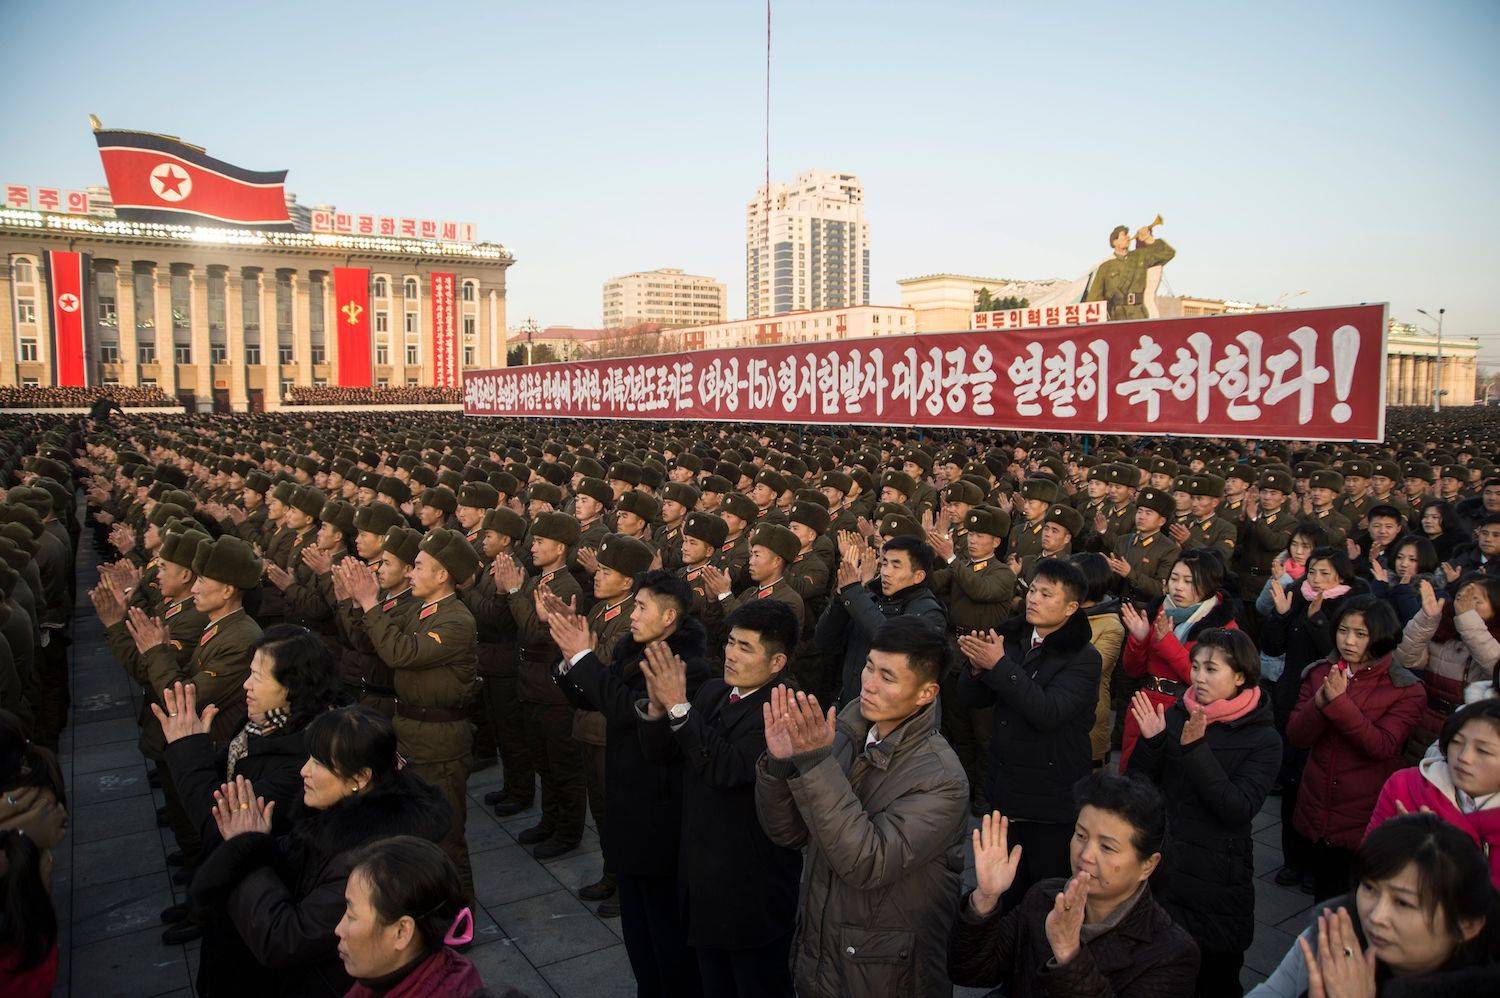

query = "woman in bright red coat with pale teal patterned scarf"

[{"left": 1121, "top": 551, "right": 1238, "bottom": 773}]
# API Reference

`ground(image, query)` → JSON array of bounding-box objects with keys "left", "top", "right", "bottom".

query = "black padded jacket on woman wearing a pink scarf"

[{"left": 1130, "top": 695, "right": 1281, "bottom": 951}]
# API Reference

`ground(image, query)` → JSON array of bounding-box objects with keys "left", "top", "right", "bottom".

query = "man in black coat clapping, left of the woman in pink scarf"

[{"left": 959, "top": 558, "right": 1103, "bottom": 908}]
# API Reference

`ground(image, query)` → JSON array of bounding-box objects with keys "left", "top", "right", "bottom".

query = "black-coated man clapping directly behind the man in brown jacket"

[{"left": 813, "top": 537, "right": 948, "bottom": 710}]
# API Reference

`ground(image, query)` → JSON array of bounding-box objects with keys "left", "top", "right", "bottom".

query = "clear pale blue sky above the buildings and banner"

[{"left": 0, "top": 0, "right": 1500, "bottom": 354}]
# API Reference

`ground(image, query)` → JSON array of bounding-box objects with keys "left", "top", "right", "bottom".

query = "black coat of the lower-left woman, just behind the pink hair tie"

[{"left": 191, "top": 770, "right": 452, "bottom": 998}]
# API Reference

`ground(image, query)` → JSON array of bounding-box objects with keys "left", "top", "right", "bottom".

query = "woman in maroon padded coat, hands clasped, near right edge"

[{"left": 1287, "top": 596, "right": 1427, "bottom": 900}]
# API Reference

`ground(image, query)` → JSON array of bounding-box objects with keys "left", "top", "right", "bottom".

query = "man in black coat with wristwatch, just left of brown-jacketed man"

[{"left": 636, "top": 599, "right": 803, "bottom": 998}]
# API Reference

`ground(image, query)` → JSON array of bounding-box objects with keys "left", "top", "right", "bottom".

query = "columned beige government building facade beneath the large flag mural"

[{"left": 0, "top": 207, "right": 515, "bottom": 411}]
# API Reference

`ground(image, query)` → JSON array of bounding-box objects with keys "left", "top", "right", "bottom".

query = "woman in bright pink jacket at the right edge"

[{"left": 1365, "top": 699, "right": 1500, "bottom": 887}]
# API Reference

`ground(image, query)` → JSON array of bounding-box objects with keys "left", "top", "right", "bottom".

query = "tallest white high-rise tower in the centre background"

[{"left": 746, "top": 170, "right": 870, "bottom": 318}]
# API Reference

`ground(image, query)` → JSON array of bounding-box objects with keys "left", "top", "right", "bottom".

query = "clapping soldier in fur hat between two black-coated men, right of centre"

[{"left": 927, "top": 506, "right": 1014, "bottom": 815}]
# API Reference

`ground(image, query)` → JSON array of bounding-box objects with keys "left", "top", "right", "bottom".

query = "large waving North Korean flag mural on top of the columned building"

[{"left": 95, "top": 129, "right": 293, "bottom": 231}]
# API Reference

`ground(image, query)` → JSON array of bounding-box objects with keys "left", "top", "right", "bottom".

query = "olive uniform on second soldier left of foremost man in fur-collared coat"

[{"left": 510, "top": 570, "right": 585, "bottom": 842}]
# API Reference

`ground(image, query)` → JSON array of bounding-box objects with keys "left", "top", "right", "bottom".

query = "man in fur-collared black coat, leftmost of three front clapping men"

[{"left": 545, "top": 569, "right": 710, "bottom": 998}]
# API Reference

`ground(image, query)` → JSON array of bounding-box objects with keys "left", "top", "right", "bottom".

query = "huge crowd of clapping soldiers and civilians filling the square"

[{"left": 0, "top": 408, "right": 1500, "bottom": 998}]
